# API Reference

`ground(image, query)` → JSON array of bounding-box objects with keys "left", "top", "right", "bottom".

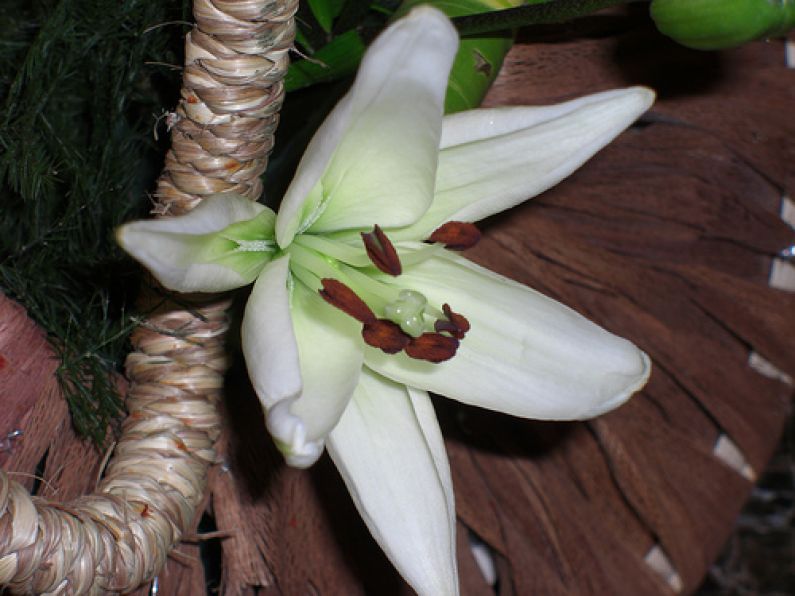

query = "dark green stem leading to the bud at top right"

[{"left": 452, "top": 0, "right": 647, "bottom": 36}]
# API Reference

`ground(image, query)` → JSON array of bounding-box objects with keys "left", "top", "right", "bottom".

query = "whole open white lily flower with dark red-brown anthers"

[{"left": 118, "top": 7, "right": 654, "bottom": 596}]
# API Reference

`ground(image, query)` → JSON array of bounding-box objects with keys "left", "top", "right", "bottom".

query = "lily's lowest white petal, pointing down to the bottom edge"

[{"left": 328, "top": 370, "right": 458, "bottom": 596}]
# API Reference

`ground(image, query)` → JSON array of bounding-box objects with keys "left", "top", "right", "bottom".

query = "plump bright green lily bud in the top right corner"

[{"left": 650, "top": 0, "right": 795, "bottom": 50}]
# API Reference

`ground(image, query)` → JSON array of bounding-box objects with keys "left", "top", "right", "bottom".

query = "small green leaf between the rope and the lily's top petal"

[{"left": 284, "top": 31, "right": 365, "bottom": 92}]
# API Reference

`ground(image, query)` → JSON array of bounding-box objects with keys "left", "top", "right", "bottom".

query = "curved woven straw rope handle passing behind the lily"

[{"left": 0, "top": 0, "right": 297, "bottom": 594}]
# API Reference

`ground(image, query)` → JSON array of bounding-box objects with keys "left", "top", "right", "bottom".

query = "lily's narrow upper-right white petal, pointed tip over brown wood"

[{"left": 391, "top": 87, "right": 654, "bottom": 240}]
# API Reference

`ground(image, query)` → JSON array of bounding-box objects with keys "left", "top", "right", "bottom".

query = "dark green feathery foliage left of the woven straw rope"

[{"left": 0, "top": 0, "right": 189, "bottom": 442}]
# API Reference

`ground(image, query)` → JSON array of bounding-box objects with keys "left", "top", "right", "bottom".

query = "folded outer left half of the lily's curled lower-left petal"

[{"left": 241, "top": 256, "right": 323, "bottom": 466}]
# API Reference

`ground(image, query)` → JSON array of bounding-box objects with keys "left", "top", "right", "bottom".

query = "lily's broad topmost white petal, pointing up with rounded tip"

[{"left": 276, "top": 7, "right": 458, "bottom": 247}]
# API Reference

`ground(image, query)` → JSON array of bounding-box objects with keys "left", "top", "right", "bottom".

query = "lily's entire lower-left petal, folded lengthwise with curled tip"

[{"left": 242, "top": 256, "right": 363, "bottom": 468}]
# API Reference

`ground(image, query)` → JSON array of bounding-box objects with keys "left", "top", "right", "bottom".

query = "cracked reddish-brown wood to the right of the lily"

[{"left": 446, "top": 11, "right": 795, "bottom": 594}]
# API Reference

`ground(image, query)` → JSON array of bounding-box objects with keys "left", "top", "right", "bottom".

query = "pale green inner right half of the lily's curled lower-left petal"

[{"left": 288, "top": 283, "right": 364, "bottom": 467}]
